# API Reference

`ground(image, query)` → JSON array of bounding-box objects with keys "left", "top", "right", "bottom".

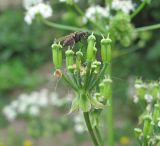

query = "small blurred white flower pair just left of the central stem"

[{"left": 73, "top": 112, "right": 86, "bottom": 134}]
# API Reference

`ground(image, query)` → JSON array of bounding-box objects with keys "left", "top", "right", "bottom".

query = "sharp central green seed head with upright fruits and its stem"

[{"left": 52, "top": 33, "right": 112, "bottom": 146}]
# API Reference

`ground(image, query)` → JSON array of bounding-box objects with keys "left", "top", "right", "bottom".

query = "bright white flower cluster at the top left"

[{"left": 24, "top": 0, "right": 53, "bottom": 25}]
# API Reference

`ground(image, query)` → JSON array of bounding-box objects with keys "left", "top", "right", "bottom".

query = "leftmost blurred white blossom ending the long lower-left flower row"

[{"left": 2, "top": 106, "right": 17, "bottom": 122}]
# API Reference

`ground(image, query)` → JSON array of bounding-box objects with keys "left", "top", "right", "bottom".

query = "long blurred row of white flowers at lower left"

[{"left": 2, "top": 89, "right": 72, "bottom": 122}]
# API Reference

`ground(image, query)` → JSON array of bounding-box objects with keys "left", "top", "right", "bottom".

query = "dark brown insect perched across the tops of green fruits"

[{"left": 58, "top": 32, "right": 89, "bottom": 47}]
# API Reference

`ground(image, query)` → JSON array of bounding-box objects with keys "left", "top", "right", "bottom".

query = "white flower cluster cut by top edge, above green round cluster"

[{"left": 112, "top": 0, "right": 135, "bottom": 14}]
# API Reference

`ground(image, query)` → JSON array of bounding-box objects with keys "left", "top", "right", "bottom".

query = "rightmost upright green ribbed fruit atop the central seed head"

[{"left": 101, "top": 37, "right": 112, "bottom": 63}]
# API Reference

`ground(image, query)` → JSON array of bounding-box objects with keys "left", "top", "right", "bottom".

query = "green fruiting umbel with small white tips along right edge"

[{"left": 134, "top": 79, "right": 160, "bottom": 146}]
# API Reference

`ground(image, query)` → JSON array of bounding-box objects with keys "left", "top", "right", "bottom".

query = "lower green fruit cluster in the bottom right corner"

[{"left": 134, "top": 104, "right": 160, "bottom": 146}]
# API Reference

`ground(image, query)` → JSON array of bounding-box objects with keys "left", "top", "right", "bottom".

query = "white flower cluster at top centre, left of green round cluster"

[{"left": 83, "top": 5, "right": 109, "bottom": 23}]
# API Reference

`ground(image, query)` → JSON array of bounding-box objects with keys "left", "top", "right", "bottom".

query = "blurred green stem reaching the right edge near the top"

[{"left": 135, "top": 24, "right": 160, "bottom": 32}]
